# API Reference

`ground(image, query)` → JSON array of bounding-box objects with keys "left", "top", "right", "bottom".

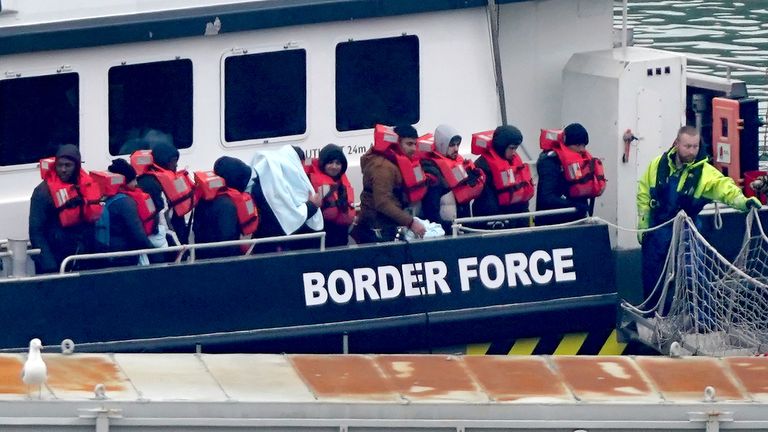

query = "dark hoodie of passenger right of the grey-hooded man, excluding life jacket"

[{"left": 472, "top": 126, "right": 529, "bottom": 228}]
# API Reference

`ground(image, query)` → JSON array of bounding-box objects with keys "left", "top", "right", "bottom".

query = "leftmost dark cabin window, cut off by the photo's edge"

[{"left": 0, "top": 73, "right": 80, "bottom": 166}]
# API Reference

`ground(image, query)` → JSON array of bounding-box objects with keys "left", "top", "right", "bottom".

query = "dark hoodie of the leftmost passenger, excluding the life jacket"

[{"left": 29, "top": 144, "right": 93, "bottom": 273}]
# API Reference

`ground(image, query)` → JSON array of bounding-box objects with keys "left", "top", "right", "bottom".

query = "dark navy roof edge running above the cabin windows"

[{"left": 0, "top": 0, "right": 525, "bottom": 55}]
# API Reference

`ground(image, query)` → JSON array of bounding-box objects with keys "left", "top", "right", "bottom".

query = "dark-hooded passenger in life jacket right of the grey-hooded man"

[{"left": 472, "top": 125, "right": 534, "bottom": 229}]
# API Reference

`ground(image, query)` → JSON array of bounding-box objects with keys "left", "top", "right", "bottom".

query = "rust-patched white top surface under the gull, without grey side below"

[{"left": 0, "top": 353, "right": 768, "bottom": 405}]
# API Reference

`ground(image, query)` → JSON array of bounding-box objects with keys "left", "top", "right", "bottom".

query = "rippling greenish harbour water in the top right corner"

[{"left": 615, "top": 0, "right": 768, "bottom": 152}]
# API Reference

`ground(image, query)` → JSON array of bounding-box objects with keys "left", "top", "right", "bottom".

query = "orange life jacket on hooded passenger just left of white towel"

[{"left": 195, "top": 171, "right": 259, "bottom": 236}]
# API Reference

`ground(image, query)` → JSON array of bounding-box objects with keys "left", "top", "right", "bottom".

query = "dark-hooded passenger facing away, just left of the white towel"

[{"left": 192, "top": 156, "right": 259, "bottom": 258}]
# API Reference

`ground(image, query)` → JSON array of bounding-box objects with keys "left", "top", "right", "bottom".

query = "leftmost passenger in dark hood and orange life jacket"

[{"left": 29, "top": 144, "right": 102, "bottom": 273}]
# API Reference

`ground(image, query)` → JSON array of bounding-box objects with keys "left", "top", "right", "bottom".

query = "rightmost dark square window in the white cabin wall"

[{"left": 336, "top": 35, "right": 419, "bottom": 131}]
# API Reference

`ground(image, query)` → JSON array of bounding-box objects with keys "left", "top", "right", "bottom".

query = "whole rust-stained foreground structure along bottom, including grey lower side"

[{"left": 0, "top": 354, "right": 768, "bottom": 432}]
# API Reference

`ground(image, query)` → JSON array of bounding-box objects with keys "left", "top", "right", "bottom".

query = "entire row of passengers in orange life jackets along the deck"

[{"left": 29, "top": 120, "right": 605, "bottom": 273}]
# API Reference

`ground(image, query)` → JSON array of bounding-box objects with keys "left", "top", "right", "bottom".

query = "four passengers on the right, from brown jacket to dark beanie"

[{"left": 352, "top": 123, "right": 605, "bottom": 243}]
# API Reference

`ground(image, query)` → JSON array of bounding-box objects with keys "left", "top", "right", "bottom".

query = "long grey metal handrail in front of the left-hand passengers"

[{"left": 59, "top": 231, "right": 325, "bottom": 274}]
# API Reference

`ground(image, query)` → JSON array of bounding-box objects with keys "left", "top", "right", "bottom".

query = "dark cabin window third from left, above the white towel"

[{"left": 224, "top": 49, "right": 307, "bottom": 142}]
